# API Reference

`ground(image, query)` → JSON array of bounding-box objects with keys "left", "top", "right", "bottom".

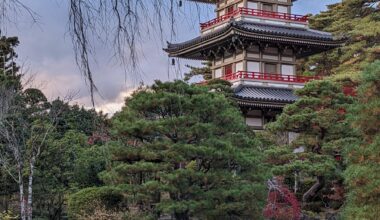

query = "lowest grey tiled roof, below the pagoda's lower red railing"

[{"left": 235, "top": 86, "right": 297, "bottom": 103}]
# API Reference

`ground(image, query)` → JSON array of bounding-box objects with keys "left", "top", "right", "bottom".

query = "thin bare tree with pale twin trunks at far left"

[{"left": 0, "top": 86, "right": 75, "bottom": 220}]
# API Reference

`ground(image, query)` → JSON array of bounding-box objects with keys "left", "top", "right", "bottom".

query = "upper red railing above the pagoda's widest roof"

[{"left": 201, "top": 8, "right": 309, "bottom": 30}]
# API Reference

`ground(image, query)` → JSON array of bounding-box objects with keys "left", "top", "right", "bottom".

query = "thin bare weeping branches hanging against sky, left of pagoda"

[{"left": 69, "top": 0, "right": 190, "bottom": 105}]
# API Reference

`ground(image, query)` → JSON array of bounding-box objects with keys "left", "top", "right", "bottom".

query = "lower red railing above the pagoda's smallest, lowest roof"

[{"left": 222, "top": 71, "right": 321, "bottom": 83}]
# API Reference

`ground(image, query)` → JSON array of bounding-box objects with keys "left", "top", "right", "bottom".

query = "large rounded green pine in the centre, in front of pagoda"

[{"left": 102, "top": 81, "right": 265, "bottom": 219}]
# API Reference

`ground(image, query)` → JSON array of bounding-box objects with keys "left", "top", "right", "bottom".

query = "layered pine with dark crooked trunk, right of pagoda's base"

[{"left": 266, "top": 80, "right": 353, "bottom": 217}]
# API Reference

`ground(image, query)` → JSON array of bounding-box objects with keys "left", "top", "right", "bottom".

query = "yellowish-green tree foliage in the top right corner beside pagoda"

[{"left": 301, "top": 0, "right": 380, "bottom": 81}]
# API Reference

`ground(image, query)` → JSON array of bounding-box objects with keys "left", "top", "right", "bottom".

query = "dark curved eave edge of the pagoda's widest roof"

[{"left": 164, "top": 24, "right": 345, "bottom": 60}]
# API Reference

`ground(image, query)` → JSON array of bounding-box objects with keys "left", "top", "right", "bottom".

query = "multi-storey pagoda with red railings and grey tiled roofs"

[{"left": 164, "top": 0, "right": 343, "bottom": 130}]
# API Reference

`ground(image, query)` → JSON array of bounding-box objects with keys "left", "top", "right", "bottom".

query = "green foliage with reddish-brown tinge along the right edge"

[{"left": 344, "top": 61, "right": 380, "bottom": 219}]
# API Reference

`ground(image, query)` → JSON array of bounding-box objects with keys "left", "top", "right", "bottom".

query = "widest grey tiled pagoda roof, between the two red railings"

[{"left": 164, "top": 19, "right": 344, "bottom": 60}]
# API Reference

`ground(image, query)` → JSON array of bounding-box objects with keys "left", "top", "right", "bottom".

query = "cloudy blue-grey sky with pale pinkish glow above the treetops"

[{"left": 2, "top": 0, "right": 340, "bottom": 114}]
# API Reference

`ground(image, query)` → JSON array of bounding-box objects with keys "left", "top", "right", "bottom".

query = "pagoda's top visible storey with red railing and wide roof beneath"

[{"left": 165, "top": 0, "right": 343, "bottom": 60}]
